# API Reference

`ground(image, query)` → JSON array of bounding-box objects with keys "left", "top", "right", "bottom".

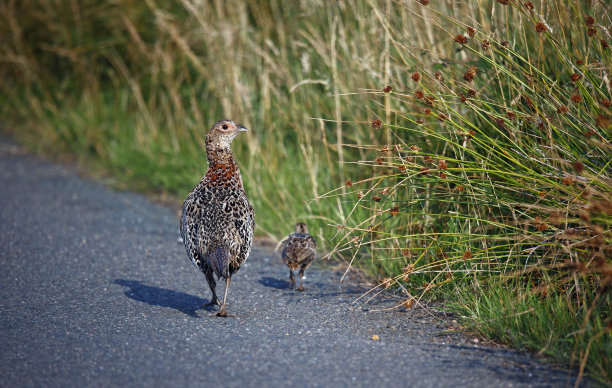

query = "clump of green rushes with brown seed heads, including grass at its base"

[{"left": 322, "top": 0, "right": 612, "bottom": 383}]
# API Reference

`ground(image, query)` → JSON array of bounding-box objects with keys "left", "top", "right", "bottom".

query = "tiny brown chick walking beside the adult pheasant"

[{"left": 278, "top": 222, "right": 317, "bottom": 291}]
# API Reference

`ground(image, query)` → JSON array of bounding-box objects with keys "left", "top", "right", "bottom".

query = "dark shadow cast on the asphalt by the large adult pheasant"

[{"left": 113, "top": 279, "right": 208, "bottom": 318}]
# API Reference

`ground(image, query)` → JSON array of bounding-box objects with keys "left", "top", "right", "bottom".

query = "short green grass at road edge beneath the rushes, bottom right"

[{"left": 453, "top": 282, "right": 612, "bottom": 382}]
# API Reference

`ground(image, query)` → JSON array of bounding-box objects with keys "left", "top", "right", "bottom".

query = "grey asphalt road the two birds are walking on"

[{"left": 0, "top": 140, "right": 574, "bottom": 387}]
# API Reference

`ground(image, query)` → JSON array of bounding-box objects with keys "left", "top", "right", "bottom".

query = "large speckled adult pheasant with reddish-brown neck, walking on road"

[{"left": 180, "top": 120, "right": 255, "bottom": 317}]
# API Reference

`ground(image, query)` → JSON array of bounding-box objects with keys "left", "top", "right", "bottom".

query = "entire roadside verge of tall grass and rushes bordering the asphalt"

[{"left": 0, "top": 0, "right": 612, "bottom": 383}]
